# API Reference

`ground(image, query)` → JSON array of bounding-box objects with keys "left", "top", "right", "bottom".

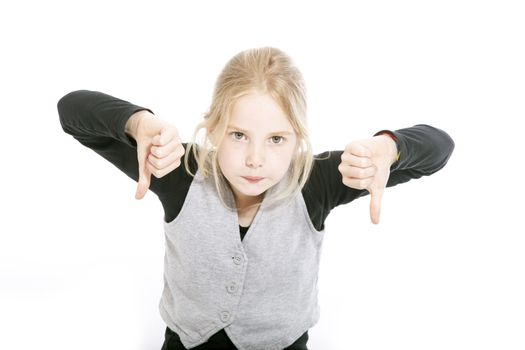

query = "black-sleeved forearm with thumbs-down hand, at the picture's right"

[{"left": 336, "top": 124, "right": 454, "bottom": 224}]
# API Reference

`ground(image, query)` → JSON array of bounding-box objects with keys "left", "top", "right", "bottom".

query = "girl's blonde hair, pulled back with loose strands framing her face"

[{"left": 184, "top": 47, "right": 313, "bottom": 209}]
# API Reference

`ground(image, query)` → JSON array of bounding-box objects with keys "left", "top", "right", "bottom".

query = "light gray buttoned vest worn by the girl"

[{"left": 159, "top": 171, "right": 324, "bottom": 350}]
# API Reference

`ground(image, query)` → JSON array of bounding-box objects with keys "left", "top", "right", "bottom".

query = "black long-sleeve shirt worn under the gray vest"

[{"left": 57, "top": 90, "right": 454, "bottom": 348}]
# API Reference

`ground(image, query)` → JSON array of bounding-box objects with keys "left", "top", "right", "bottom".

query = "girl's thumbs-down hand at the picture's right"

[{"left": 338, "top": 135, "right": 397, "bottom": 224}]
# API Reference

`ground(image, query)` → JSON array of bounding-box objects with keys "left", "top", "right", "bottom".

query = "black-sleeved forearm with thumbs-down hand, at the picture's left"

[{"left": 57, "top": 90, "right": 184, "bottom": 199}]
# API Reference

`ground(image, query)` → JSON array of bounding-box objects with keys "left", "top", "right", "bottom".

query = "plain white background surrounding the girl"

[{"left": 0, "top": 0, "right": 525, "bottom": 350}]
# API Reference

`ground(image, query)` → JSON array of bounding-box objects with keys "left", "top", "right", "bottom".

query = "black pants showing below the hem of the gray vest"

[{"left": 161, "top": 327, "right": 308, "bottom": 350}]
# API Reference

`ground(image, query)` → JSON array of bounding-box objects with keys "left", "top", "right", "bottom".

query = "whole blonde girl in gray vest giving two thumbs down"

[{"left": 58, "top": 48, "right": 454, "bottom": 350}]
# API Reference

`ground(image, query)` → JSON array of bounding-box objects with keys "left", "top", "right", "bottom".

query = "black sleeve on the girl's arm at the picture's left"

[{"left": 57, "top": 90, "right": 194, "bottom": 218}]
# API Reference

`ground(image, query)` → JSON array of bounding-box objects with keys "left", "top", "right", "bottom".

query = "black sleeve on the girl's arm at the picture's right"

[{"left": 303, "top": 124, "right": 454, "bottom": 230}]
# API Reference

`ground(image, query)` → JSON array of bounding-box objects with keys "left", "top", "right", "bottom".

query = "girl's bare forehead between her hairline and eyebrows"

[{"left": 229, "top": 93, "right": 293, "bottom": 133}]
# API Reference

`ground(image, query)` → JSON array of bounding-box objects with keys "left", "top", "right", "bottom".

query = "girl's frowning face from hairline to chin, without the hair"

[{"left": 217, "top": 93, "right": 297, "bottom": 207}]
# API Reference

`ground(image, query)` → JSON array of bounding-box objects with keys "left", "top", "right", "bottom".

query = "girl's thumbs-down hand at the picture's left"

[{"left": 126, "top": 111, "right": 185, "bottom": 199}]
